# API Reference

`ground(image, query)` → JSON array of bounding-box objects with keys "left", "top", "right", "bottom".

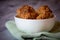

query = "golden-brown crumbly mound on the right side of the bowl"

[{"left": 36, "top": 5, "right": 53, "bottom": 19}]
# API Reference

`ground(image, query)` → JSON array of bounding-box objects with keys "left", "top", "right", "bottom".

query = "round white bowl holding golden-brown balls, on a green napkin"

[{"left": 14, "top": 17, "right": 55, "bottom": 33}]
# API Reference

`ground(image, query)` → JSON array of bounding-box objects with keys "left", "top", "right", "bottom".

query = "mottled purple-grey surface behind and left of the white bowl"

[{"left": 0, "top": 0, "right": 60, "bottom": 40}]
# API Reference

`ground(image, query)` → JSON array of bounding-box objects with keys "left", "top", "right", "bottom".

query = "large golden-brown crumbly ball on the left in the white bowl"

[{"left": 17, "top": 5, "right": 38, "bottom": 19}]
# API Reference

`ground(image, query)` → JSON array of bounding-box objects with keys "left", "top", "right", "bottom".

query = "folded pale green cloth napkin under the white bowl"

[{"left": 5, "top": 21, "right": 60, "bottom": 40}]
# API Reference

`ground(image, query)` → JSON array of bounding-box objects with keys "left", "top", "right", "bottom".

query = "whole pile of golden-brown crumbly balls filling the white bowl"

[{"left": 16, "top": 5, "right": 54, "bottom": 19}]
